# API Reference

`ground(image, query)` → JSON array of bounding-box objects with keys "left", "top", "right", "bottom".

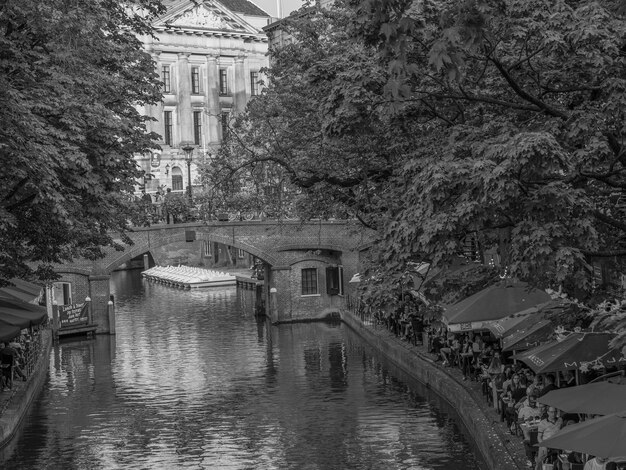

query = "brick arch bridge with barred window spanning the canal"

[{"left": 56, "top": 220, "right": 373, "bottom": 333}]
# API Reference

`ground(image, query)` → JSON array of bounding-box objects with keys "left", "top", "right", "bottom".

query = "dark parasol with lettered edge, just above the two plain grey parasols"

[{"left": 513, "top": 332, "right": 626, "bottom": 374}]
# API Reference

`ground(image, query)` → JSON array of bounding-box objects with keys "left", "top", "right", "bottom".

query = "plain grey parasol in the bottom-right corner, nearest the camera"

[{"left": 538, "top": 411, "right": 626, "bottom": 458}]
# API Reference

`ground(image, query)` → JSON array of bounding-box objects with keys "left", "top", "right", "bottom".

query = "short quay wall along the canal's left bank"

[{"left": 0, "top": 328, "right": 52, "bottom": 453}]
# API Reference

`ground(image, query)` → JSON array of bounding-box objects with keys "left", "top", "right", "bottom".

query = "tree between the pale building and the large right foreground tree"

[{"left": 207, "top": 2, "right": 410, "bottom": 227}]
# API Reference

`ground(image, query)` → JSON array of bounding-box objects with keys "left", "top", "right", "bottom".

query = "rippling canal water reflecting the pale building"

[{"left": 0, "top": 271, "right": 484, "bottom": 470}]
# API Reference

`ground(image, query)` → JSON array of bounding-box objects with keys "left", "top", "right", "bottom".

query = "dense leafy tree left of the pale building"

[{"left": 0, "top": 0, "right": 163, "bottom": 283}]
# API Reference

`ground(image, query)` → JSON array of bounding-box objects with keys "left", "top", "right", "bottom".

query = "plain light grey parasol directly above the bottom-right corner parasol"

[{"left": 537, "top": 382, "right": 626, "bottom": 415}]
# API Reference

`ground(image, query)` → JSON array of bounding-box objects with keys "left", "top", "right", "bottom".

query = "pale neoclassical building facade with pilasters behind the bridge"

[{"left": 137, "top": 0, "right": 270, "bottom": 194}]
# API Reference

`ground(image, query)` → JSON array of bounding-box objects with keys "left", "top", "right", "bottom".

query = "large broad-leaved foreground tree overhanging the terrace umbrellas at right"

[{"left": 352, "top": 0, "right": 626, "bottom": 340}]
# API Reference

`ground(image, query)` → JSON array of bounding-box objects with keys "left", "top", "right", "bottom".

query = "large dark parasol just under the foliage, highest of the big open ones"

[{"left": 444, "top": 282, "right": 551, "bottom": 331}]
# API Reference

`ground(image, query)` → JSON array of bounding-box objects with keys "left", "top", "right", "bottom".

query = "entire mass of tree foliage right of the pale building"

[{"left": 212, "top": 0, "right": 626, "bottom": 344}]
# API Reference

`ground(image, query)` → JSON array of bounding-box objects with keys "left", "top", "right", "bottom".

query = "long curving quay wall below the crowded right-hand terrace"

[{"left": 341, "top": 310, "right": 526, "bottom": 470}]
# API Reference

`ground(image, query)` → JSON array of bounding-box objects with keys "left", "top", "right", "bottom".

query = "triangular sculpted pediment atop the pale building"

[{"left": 155, "top": 0, "right": 259, "bottom": 34}]
